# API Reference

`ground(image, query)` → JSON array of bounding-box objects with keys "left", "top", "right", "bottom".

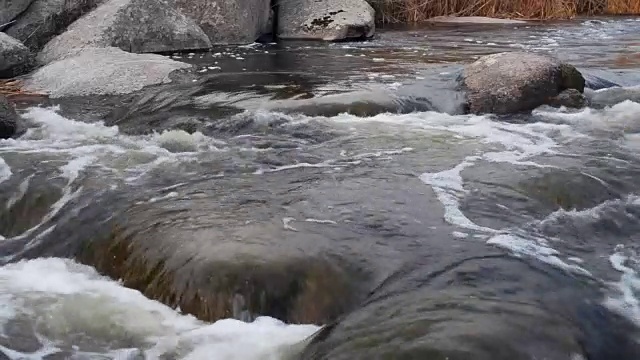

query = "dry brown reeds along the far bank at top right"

[{"left": 368, "top": 0, "right": 640, "bottom": 23}]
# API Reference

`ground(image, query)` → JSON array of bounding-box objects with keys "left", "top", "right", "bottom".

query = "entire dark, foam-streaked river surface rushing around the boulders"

[{"left": 0, "top": 18, "right": 640, "bottom": 360}]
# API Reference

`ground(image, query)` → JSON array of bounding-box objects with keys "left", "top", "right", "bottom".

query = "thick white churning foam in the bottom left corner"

[{"left": 0, "top": 258, "right": 319, "bottom": 360}]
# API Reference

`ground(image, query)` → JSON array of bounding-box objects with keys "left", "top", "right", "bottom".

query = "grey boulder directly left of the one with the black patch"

[{"left": 170, "top": 0, "right": 271, "bottom": 45}]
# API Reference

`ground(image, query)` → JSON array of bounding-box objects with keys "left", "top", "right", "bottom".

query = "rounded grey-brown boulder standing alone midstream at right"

[{"left": 459, "top": 52, "right": 584, "bottom": 114}]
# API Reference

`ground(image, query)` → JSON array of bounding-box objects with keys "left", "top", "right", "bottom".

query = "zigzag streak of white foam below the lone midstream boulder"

[{"left": 324, "top": 112, "right": 590, "bottom": 276}]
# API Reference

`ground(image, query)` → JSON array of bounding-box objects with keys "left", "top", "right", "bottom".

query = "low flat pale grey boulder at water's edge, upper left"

[{"left": 24, "top": 48, "right": 191, "bottom": 98}]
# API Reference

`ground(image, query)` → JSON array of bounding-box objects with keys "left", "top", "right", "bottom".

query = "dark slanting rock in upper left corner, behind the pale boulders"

[{"left": 5, "top": 0, "right": 103, "bottom": 53}]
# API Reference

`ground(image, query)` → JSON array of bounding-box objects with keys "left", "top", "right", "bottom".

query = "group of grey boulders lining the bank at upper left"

[{"left": 0, "top": 0, "right": 375, "bottom": 137}]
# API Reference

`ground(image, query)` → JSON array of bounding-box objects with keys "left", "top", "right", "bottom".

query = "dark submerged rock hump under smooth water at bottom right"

[{"left": 299, "top": 255, "right": 640, "bottom": 360}]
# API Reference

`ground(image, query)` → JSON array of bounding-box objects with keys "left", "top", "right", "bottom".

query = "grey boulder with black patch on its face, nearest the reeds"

[{"left": 278, "top": 0, "right": 375, "bottom": 41}]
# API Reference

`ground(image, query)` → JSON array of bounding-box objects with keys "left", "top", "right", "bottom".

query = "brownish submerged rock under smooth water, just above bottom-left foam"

[{"left": 72, "top": 177, "right": 370, "bottom": 324}]
